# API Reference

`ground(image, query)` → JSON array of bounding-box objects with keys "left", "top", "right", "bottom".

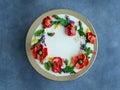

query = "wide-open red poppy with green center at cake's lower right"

[{"left": 72, "top": 53, "right": 89, "bottom": 69}]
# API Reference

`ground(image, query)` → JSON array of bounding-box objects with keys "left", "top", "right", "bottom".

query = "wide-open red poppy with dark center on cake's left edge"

[{"left": 31, "top": 44, "right": 48, "bottom": 63}]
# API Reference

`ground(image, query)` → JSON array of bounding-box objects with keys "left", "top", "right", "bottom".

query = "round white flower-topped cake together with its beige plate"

[{"left": 26, "top": 10, "right": 97, "bottom": 81}]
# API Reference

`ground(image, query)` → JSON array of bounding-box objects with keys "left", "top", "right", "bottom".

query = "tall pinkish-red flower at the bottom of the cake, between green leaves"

[{"left": 52, "top": 57, "right": 63, "bottom": 73}]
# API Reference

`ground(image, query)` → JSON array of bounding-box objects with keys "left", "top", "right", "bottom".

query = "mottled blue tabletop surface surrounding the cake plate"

[{"left": 0, "top": 0, "right": 120, "bottom": 90}]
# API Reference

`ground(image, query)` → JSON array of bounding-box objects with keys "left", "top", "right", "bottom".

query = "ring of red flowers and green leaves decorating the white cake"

[{"left": 31, "top": 15, "right": 96, "bottom": 74}]
